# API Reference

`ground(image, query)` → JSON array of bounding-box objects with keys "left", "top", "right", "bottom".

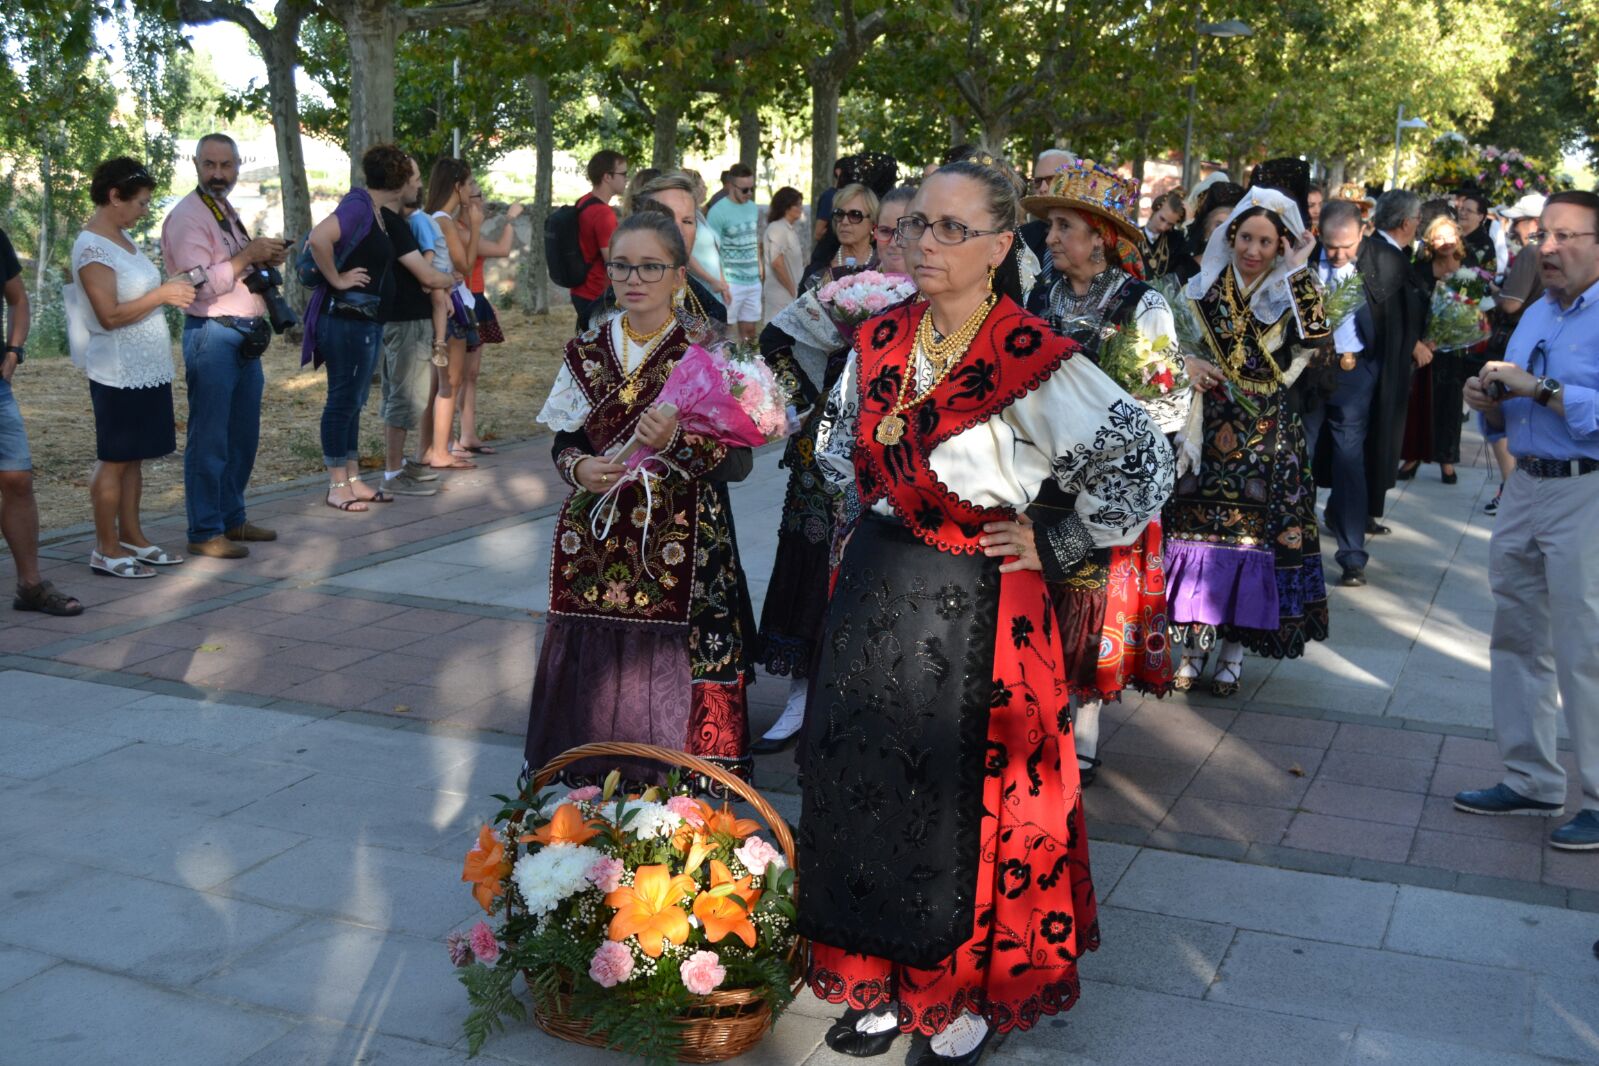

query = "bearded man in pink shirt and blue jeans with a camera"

[{"left": 161, "top": 133, "right": 293, "bottom": 559}]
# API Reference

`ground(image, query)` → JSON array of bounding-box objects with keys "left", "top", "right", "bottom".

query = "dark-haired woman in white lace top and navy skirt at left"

[{"left": 72, "top": 157, "right": 195, "bottom": 577}]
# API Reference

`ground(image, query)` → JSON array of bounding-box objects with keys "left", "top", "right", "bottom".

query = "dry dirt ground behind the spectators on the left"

[{"left": 10, "top": 305, "right": 574, "bottom": 551}]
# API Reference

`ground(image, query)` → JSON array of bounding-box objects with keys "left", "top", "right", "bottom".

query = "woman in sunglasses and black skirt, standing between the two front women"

[{"left": 753, "top": 184, "right": 878, "bottom": 754}]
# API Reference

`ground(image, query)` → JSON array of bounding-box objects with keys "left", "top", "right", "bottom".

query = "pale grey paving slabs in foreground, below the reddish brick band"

[{"left": 0, "top": 671, "right": 1599, "bottom": 1066}]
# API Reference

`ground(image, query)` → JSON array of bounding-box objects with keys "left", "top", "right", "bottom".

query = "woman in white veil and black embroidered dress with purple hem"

[{"left": 1161, "top": 185, "right": 1332, "bottom": 695}]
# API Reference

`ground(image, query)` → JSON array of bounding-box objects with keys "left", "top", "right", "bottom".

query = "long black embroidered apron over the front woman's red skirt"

[{"left": 796, "top": 515, "right": 999, "bottom": 967}]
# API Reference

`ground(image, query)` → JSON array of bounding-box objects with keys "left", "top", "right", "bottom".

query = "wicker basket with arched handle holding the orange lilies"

[{"left": 532, "top": 742, "right": 804, "bottom": 1063}]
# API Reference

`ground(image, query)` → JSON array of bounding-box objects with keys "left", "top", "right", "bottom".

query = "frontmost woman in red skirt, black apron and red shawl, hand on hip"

[{"left": 798, "top": 161, "right": 1172, "bottom": 1066}]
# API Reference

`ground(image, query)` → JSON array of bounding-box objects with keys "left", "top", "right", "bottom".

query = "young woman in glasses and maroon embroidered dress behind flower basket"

[{"left": 526, "top": 211, "right": 752, "bottom": 780}]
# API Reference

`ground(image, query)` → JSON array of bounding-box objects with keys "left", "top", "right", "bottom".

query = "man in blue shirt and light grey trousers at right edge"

[{"left": 1455, "top": 192, "right": 1599, "bottom": 852}]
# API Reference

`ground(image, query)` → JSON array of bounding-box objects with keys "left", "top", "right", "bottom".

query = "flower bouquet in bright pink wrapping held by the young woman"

[{"left": 617, "top": 344, "right": 788, "bottom": 468}]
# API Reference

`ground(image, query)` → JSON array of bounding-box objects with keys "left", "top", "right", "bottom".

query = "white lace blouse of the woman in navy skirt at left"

[{"left": 72, "top": 230, "right": 173, "bottom": 388}]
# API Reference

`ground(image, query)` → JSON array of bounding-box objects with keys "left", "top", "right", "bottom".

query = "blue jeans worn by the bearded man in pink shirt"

[{"left": 184, "top": 318, "right": 265, "bottom": 543}]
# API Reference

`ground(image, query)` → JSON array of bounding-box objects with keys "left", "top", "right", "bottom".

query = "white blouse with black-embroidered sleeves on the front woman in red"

[{"left": 817, "top": 335, "right": 1174, "bottom": 548}]
